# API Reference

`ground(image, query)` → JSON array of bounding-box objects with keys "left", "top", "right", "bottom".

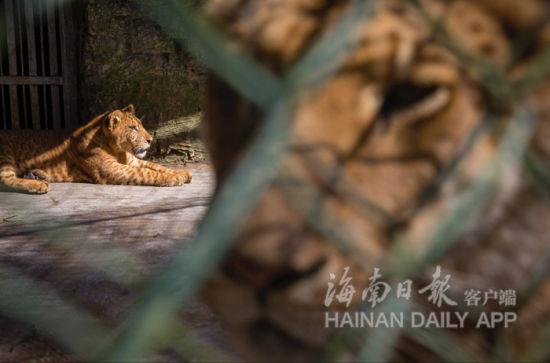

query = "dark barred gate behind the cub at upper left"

[{"left": 0, "top": 0, "right": 78, "bottom": 129}]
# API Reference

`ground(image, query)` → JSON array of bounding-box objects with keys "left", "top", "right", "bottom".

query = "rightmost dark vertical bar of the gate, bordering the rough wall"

[{"left": 58, "top": 2, "right": 78, "bottom": 127}]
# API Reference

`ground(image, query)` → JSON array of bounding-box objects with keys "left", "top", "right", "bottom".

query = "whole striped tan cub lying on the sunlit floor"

[{"left": 0, "top": 105, "right": 191, "bottom": 194}]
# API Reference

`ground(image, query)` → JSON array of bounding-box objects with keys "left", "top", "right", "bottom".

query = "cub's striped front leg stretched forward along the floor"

[{"left": 95, "top": 160, "right": 190, "bottom": 187}]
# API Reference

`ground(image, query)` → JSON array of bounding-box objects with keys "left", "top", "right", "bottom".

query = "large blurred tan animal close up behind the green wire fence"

[{"left": 203, "top": 0, "right": 550, "bottom": 361}]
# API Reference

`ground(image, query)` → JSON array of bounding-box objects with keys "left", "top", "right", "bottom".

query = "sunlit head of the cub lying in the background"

[{"left": 103, "top": 105, "right": 153, "bottom": 159}]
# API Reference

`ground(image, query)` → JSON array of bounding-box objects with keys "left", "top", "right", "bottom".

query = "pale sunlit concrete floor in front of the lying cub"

[{"left": 0, "top": 164, "right": 229, "bottom": 361}]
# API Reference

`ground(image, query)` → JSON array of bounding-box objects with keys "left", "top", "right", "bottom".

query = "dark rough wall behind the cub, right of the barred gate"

[{"left": 80, "top": 0, "right": 204, "bottom": 127}]
